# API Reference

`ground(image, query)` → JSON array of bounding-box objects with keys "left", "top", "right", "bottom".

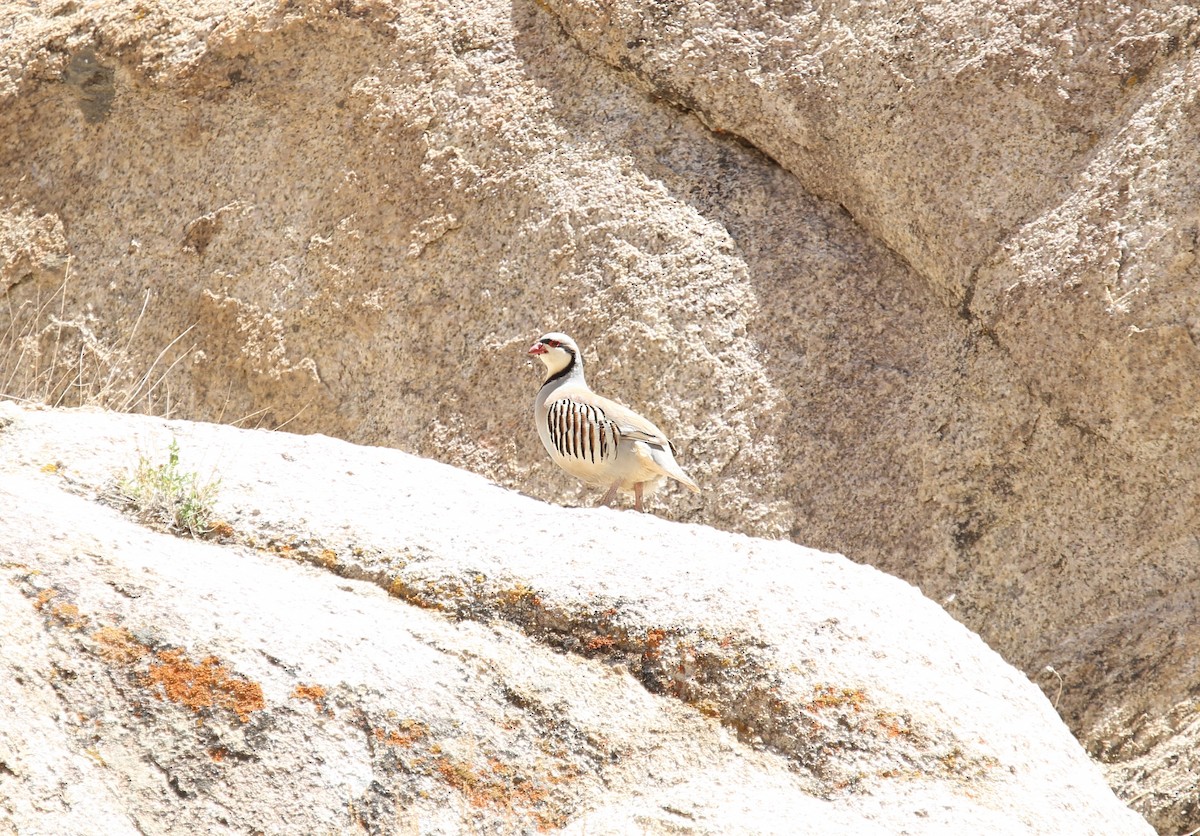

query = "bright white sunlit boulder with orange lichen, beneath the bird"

[{"left": 0, "top": 404, "right": 1152, "bottom": 836}]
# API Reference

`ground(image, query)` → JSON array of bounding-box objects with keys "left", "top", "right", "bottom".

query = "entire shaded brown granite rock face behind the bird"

[{"left": 0, "top": 0, "right": 1200, "bottom": 831}]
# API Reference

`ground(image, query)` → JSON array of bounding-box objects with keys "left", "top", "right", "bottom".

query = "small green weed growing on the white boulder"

[{"left": 112, "top": 439, "right": 221, "bottom": 537}]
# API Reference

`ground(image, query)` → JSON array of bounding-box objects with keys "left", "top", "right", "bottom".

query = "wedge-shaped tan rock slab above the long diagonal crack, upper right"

[{"left": 547, "top": 0, "right": 1200, "bottom": 302}]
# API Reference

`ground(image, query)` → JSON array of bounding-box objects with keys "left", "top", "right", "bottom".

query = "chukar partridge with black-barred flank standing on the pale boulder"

[{"left": 528, "top": 331, "right": 700, "bottom": 511}]
